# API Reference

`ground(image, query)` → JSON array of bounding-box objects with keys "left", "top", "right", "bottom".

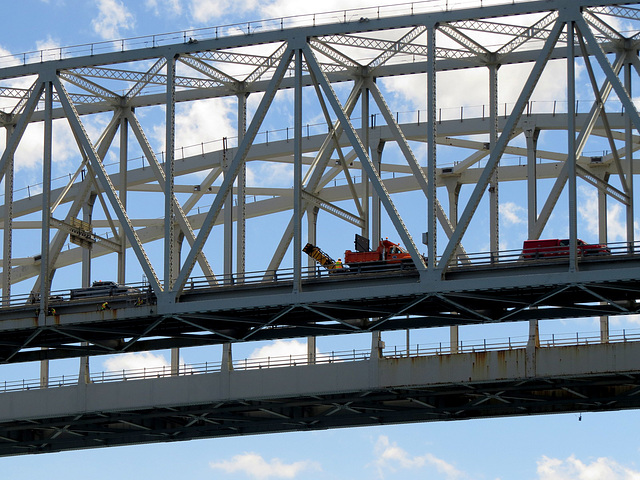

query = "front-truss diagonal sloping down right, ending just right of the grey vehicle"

[{"left": 53, "top": 78, "right": 162, "bottom": 292}]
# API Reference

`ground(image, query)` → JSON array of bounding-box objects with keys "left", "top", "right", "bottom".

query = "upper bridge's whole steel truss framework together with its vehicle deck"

[{"left": 0, "top": 0, "right": 640, "bottom": 368}]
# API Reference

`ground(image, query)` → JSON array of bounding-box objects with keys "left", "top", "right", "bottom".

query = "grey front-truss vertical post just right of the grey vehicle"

[{"left": 164, "top": 57, "right": 176, "bottom": 292}]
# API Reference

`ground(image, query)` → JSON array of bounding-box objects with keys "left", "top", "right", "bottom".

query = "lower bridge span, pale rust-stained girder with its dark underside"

[{"left": 0, "top": 342, "right": 640, "bottom": 456}]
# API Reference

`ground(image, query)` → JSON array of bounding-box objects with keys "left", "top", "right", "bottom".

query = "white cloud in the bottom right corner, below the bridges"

[{"left": 537, "top": 455, "right": 640, "bottom": 480}]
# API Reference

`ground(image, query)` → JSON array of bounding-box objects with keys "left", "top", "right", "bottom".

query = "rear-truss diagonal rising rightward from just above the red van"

[{"left": 531, "top": 54, "right": 626, "bottom": 240}]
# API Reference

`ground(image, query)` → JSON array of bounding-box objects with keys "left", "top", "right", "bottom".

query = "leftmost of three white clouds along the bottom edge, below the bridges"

[{"left": 209, "top": 452, "right": 321, "bottom": 480}]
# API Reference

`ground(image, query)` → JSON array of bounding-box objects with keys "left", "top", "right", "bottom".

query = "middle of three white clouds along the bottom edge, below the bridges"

[{"left": 372, "top": 435, "right": 466, "bottom": 480}]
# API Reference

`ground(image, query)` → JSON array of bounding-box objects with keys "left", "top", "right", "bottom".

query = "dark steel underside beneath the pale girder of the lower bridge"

[{"left": 0, "top": 354, "right": 640, "bottom": 456}]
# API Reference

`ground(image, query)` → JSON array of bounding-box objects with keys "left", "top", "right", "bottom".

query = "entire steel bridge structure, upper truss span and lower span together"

[{"left": 0, "top": 0, "right": 640, "bottom": 455}]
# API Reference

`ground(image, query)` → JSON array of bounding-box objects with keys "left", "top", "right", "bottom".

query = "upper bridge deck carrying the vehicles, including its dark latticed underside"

[{"left": 0, "top": 256, "right": 640, "bottom": 363}]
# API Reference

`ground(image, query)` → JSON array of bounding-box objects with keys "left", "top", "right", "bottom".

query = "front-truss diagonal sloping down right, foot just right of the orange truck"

[{"left": 302, "top": 45, "right": 426, "bottom": 273}]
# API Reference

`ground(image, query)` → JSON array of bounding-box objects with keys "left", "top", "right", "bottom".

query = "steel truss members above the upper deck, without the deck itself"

[{"left": 0, "top": 0, "right": 640, "bottom": 312}]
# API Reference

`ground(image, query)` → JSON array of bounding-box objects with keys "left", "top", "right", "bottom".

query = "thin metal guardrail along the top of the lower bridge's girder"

[{"left": 0, "top": 329, "right": 640, "bottom": 393}]
